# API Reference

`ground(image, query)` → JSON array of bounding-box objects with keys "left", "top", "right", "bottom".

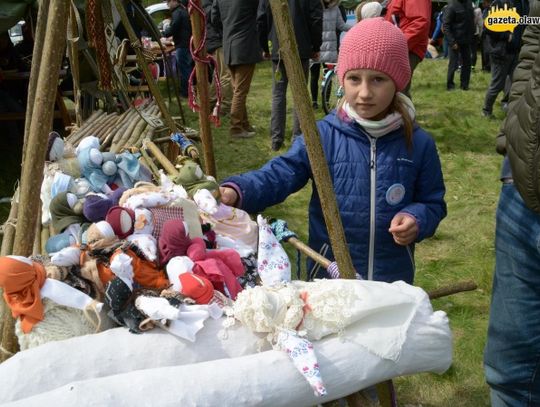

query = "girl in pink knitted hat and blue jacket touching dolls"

[{"left": 217, "top": 18, "right": 446, "bottom": 283}]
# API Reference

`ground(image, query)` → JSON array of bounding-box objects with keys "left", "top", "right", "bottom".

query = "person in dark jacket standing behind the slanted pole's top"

[{"left": 257, "top": 0, "right": 323, "bottom": 151}]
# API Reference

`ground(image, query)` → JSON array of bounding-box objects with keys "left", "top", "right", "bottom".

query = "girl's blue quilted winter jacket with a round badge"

[{"left": 224, "top": 112, "right": 446, "bottom": 283}]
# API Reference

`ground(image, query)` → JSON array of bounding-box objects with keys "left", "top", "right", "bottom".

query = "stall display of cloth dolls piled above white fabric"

[{"left": 0, "top": 135, "right": 452, "bottom": 406}]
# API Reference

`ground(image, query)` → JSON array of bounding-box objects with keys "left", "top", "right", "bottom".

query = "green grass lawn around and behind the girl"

[{"left": 181, "top": 60, "right": 503, "bottom": 407}]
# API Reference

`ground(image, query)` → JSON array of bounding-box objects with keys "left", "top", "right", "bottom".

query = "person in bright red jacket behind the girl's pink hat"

[{"left": 385, "top": 0, "right": 431, "bottom": 98}]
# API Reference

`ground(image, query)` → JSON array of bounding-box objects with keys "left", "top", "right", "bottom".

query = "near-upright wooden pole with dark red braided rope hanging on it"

[{"left": 190, "top": 0, "right": 216, "bottom": 178}]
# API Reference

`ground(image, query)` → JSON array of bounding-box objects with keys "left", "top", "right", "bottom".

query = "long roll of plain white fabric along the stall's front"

[{"left": 0, "top": 282, "right": 452, "bottom": 407}]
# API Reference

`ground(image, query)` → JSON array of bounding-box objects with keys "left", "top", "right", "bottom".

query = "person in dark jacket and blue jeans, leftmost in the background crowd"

[{"left": 163, "top": 0, "right": 193, "bottom": 97}]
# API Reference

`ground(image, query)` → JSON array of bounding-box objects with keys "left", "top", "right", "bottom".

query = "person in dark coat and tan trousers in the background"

[{"left": 211, "top": 0, "right": 261, "bottom": 138}]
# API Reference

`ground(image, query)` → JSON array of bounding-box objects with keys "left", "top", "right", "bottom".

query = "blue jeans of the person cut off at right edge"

[{"left": 484, "top": 184, "right": 540, "bottom": 407}]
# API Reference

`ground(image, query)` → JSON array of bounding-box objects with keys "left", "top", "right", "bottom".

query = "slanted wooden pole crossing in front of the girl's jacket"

[{"left": 269, "top": 0, "right": 356, "bottom": 279}]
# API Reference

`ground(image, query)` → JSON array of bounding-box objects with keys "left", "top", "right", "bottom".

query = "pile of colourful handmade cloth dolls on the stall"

[{"left": 0, "top": 133, "right": 258, "bottom": 342}]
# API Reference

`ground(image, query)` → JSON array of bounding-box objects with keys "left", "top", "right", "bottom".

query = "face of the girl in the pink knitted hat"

[{"left": 343, "top": 69, "right": 396, "bottom": 120}]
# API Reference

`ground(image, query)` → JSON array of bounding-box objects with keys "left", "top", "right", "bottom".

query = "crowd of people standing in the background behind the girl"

[{"left": 162, "top": 0, "right": 528, "bottom": 151}]
